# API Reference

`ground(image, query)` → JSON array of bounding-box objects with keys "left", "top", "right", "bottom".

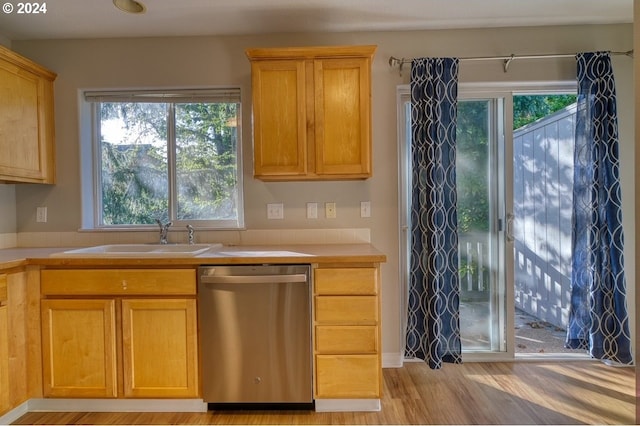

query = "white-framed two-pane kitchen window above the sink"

[{"left": 82, "top": 88, "right": 243, "bottom": 229}]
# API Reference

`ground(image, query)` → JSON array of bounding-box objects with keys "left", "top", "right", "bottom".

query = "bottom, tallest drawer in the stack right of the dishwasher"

[{"left": 316, "top": 355, "right": 380, "bottom": 398}]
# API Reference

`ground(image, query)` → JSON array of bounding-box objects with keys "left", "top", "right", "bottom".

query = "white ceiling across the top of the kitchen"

[{"left": 0, "top": 0, "right": 633, "bottom": 40}]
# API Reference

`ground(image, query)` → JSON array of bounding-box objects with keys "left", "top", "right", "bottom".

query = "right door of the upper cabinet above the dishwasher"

[{"left": 314, "top": 58, "right": 371, "bottom": 178}]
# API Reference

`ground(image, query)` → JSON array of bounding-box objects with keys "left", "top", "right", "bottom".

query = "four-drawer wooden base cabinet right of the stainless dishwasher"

[{"left": 314, "top": 265, "right": 382, "bottom": 399}]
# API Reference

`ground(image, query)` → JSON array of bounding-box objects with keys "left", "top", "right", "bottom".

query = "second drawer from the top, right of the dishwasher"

[{"left": 315, "top": 296, "right": 378, "bottom": 325}]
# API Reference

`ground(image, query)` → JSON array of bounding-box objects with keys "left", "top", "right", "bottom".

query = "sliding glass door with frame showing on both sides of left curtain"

[{"left": 398, "top": 86, "right": 513, "bottom": 360}]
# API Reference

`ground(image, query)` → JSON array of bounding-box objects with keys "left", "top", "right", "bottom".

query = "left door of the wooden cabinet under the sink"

[{"left": 41, "top": 299, "right": 117, "bottom": 398}]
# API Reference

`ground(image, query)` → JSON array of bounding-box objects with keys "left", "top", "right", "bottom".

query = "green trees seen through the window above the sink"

[{"left": 100, "top": 102, "right": 239, "bottom": 225}]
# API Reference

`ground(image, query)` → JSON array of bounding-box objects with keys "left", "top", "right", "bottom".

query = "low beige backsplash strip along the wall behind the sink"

[{"left": 16, "top": 228, "right": 371, "bottom": 248}]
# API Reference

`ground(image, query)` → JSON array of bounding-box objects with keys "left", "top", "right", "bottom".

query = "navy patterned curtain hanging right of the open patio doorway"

[{"left": 566, "top": 52, "right": 632, "bottom": 364}]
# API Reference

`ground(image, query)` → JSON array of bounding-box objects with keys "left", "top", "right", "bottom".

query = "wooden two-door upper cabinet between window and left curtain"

[{"left": 246, "top": 46, "right": 376, "bottom": 181}]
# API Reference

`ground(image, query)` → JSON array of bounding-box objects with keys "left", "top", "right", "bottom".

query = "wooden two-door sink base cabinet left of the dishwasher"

[{"left": 41, "top": 269, "right": 199, "bottom": 398}]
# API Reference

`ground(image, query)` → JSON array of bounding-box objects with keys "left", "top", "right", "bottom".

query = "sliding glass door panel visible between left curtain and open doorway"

[{"left": 456, "top": 96, "right": 512, "bottom": 354}]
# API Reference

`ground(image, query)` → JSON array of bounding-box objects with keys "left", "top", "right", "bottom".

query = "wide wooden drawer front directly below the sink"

[{"left": 40, "top": 269, "right": 196, "bottom": 296}]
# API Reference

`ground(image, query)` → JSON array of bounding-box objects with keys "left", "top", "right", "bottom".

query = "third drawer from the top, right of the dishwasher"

[{"left": 316, "top": 325, "right": 378, "bottom": 354}]
